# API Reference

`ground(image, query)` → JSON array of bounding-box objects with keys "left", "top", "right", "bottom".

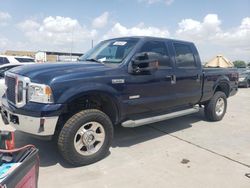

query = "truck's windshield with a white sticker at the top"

[{"left": 79, "top": 38, "right": 138, "bottom": 64}]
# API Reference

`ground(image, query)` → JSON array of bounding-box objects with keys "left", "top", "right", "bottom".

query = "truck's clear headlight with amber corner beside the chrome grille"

[{"left": 28, "top": 83, "right": 54, "bottom": 103}]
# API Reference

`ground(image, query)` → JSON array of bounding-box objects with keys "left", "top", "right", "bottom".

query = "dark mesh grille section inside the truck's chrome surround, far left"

[{"left": 5, "top": 76, "right": 16, "bottom": 104}]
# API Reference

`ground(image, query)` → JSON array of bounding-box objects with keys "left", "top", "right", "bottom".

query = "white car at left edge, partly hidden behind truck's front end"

[{"left": 0, "top": 63, "right": 33, "bottom": 107}]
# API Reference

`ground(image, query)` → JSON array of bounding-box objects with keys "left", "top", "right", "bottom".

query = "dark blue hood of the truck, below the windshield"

[{"left": 10, "top": 62, "right": 110, "bottom": 83}]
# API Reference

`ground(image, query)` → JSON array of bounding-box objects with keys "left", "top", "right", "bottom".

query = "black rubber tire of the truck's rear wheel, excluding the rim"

[{"left": 204, "top": 91, "right": 227, "bottom": 121}]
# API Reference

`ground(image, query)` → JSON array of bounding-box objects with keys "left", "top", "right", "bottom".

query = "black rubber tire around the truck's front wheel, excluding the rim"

[{"left": 57, "top": 109, "right": 113, "bottom": 166}]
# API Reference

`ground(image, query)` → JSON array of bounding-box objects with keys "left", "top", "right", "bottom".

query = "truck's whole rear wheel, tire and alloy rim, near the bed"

[{"left": 204, "top": 91, "right": 227, "bottom": 121}]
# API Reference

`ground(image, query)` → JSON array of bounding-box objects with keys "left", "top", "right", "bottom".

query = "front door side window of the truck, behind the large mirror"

[{"left": 140, "top": 41, "right": 172, "bottom": 67}]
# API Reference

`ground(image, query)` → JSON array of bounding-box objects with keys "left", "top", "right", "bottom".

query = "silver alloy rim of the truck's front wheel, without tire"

[{"left": 74, "top": 122, "right": 105, "bottom": 156}]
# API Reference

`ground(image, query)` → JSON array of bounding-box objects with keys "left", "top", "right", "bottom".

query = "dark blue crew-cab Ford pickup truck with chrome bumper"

[{"left": 2, "top": 37, "right": 238, "bottom": 166}]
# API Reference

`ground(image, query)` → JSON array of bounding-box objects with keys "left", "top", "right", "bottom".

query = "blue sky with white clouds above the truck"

[{"left": 0, "top": 0, "right": 250, "bottom": 62}]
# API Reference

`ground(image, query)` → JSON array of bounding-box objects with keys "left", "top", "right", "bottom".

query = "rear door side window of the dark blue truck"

[{"left": 174, "top": 43, "right": 196, "bottom": 68}]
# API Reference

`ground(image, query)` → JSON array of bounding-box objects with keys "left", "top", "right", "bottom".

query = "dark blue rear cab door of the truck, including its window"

[{"left": 172, "top": 41, "right": 202, "bottom": 105}]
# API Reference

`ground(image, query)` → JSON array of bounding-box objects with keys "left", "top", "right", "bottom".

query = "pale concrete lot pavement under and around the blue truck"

[{"left": 0, "top": 88, "right": 250, "bottom": 188}]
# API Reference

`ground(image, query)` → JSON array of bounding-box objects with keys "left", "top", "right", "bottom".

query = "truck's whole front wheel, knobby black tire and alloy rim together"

[{"left": 58, "top": 109, "right": 113, "bottom": 166}]
